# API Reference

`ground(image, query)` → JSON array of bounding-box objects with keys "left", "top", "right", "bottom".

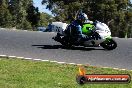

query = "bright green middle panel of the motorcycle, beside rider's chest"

[{"left": 82, "top": 24, "right": 94, "bottom": 35}]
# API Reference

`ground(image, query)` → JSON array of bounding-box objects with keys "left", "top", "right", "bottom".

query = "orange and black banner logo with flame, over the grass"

[{"left": 76, "top": 67, "right": 131, "bottom": 84}]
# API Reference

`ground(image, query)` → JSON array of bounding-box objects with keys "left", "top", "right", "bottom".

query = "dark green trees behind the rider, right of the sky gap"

[{"left": 42, "top": 0, "right": 132, "bottom": 37}]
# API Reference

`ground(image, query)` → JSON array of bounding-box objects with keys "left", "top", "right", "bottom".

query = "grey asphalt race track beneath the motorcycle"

[{"left": 0, "top": 29, "right": 132, "bottom": 70}]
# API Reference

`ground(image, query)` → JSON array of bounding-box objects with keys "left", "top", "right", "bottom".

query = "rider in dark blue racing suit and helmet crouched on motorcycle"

[{"left": 67, "top": 12, "right": 93, "bottom": 42}]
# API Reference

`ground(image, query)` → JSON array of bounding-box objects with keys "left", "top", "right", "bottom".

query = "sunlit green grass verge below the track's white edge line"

[{"left": 0, "top": 58, "right": 132, "bottom": 88}]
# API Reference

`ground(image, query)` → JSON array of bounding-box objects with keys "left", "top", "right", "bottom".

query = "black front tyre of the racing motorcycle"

[{"left": 100, "top": 39, "right": 117, "bottom": 50}]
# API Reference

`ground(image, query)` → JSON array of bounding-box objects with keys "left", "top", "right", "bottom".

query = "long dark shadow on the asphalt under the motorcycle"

[{"left": 32, "top": 45, "right": 105, "bottom": 51}]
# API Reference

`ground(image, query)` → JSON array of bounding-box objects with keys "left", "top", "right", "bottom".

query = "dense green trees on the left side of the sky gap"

[{"left": 0, "top": 0, "right": 51, "bottom": 30}]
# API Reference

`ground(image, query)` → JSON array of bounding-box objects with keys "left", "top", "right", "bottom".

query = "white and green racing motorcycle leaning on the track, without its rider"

[{"left": 50, "top": 21, "right": 117, "bottom": 50}]
